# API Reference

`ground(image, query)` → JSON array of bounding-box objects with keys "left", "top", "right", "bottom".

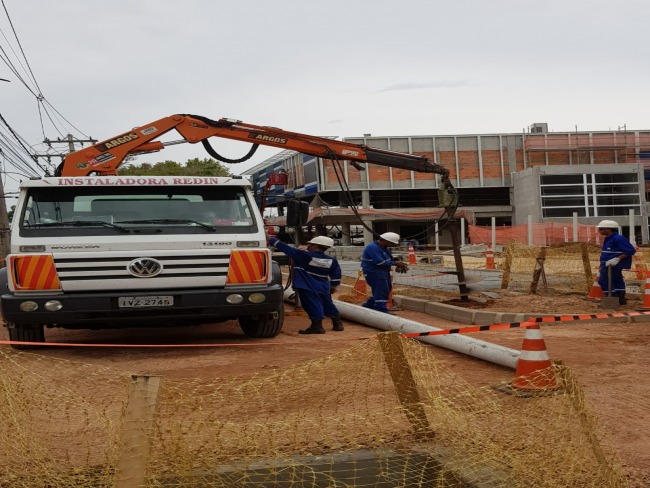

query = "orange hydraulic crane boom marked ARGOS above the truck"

[{"left": 56, "top": 114, "right": 449, "bottom": 180}]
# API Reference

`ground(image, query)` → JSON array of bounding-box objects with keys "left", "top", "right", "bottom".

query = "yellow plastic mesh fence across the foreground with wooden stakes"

[{"left": 0, "top": 332, "right": 628, "bottom": 488}]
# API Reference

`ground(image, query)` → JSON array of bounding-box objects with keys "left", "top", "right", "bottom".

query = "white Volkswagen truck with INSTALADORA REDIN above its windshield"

[{"left": 0, "top": 176, "right": 283, "bottom": 348}]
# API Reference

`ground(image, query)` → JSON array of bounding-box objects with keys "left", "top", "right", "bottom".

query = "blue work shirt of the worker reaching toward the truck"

[{"left": 269, "top": 237, "right": 341, "bottom": 295}]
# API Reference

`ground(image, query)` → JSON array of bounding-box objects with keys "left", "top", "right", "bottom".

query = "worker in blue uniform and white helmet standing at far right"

[{"left": 596, "top": 220, "right": 636, "bottom": 305}]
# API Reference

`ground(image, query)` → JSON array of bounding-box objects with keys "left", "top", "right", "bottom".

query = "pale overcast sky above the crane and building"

[{"left": 0, "top": 0, "right": 650, "bottom": 193}]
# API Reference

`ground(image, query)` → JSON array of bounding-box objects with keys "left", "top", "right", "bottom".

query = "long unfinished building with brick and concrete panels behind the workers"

[{"left": 246, "top": 123, "right": 650, "bottom": 246}]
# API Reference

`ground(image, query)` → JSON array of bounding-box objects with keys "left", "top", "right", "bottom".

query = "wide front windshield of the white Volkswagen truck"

[{"left": 20, "top": 186, "right": 258, "bottom": 235}]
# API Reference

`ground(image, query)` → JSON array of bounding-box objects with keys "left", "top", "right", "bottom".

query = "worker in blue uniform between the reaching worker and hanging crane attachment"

[{"left": 361, "top": 232, "right": 408, "bottom": 313}]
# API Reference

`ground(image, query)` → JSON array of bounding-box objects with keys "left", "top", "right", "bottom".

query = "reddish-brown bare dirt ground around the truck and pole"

[{"left": 0, "top": 286, "right": 650, "bottom": 487}]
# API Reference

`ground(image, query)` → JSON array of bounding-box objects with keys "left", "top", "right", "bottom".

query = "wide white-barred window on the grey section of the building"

[{"left": 540, "top": 173, "right": 641, "bottom": 218}]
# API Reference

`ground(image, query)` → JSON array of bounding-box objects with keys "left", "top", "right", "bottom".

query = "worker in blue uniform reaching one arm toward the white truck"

[{"left": 269, "top": 236, "right": 343, "bottom": 334}]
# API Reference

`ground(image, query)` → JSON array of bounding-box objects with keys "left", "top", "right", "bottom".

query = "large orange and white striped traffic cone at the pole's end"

[{"left": 510, "top": 322, "right": 558, "bottom": 390}]
